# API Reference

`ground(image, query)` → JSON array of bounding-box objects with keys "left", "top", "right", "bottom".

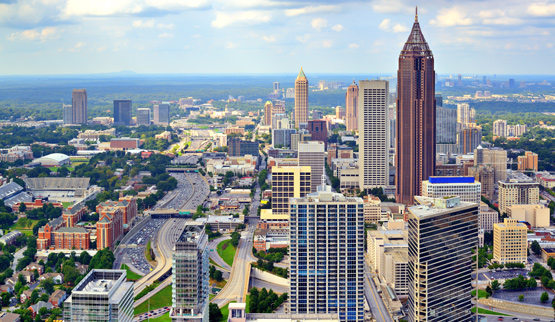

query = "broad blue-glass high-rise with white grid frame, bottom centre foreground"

[{"left": 289, "top": 186, "right": 364, "bottom": 322}]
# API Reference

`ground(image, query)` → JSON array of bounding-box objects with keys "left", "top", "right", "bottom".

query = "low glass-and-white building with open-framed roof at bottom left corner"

[{"left": 63, "top": 269, "right": 134, "bottom": 322}]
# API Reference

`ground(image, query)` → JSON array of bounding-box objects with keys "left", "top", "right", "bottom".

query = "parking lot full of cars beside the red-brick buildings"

[{"left": 124, "top": 219, "right": 166, "bottom": 274}]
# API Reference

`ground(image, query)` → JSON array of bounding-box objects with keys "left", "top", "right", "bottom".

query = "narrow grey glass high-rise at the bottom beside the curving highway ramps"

[{"left": 170, "top": 221, "right": 210, "bottom": 322}]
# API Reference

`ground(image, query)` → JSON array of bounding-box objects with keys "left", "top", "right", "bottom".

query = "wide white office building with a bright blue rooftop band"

[{"left": 422, "top": 177, "right": 482, "bottom": 204}]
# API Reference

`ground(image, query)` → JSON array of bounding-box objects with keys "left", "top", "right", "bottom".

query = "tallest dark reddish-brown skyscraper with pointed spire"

[{"left": 395, "top": 11, "right": 436, "bottom": 205}]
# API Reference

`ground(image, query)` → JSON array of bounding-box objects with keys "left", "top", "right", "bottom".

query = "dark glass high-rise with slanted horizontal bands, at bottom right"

[{"left": 407, "top": 197, "right": 478, "bottom": 322}]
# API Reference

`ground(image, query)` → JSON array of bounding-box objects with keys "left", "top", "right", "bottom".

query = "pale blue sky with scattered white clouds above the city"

[{"left": 0, "top": 0, "right": 555, "bottom": 75}]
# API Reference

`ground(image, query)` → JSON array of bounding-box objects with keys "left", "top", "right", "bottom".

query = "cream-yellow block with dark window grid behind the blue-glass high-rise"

[{"left": 272, "top": 166, "right": 311, "bottom": 215}]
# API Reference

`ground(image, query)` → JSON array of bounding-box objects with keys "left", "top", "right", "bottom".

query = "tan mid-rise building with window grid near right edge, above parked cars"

[{"left": 493, "top": 218, "right": 528, "bottom": 265}]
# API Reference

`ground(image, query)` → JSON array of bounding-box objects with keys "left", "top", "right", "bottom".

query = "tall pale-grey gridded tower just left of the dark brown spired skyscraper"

[{"left": 358, "top": 80, "right": 389, "bottom": 190}]
